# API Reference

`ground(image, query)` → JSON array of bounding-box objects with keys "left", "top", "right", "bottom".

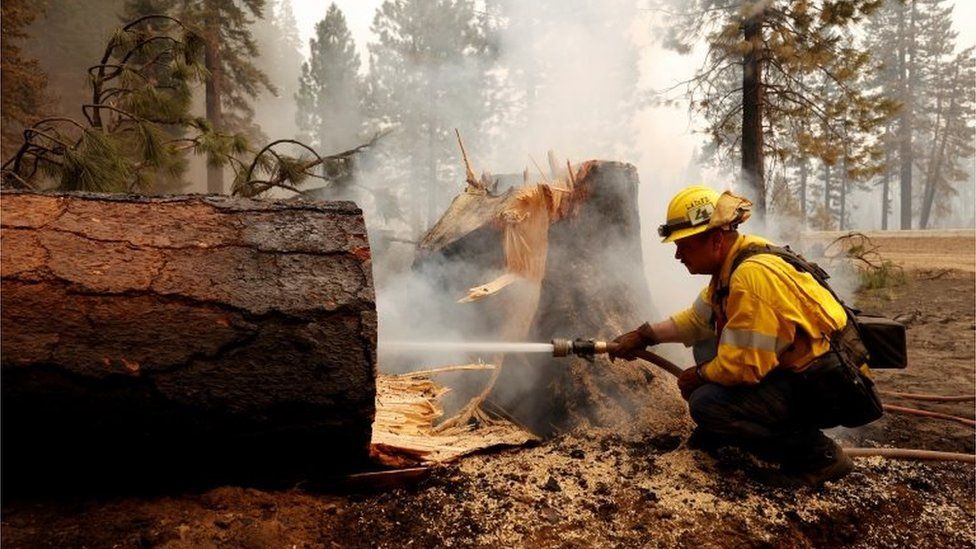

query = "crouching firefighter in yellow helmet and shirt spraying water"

[{"left": 611, "top": 186, "right": 882, "bottom": 486}]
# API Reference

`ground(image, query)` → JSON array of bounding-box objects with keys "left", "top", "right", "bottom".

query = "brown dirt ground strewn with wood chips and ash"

[{"left": 0, "top": 231, "right": 976, "bottom": 548}]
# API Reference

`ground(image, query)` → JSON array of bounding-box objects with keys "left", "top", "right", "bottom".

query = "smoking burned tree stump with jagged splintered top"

[{"left": 415, "top": 161, "right": 685, "bottom": 435}]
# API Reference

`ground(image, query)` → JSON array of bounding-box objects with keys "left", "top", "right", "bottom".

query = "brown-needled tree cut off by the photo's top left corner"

[{"left": 0, "top": 0, "right": 49, "bottom": 158}]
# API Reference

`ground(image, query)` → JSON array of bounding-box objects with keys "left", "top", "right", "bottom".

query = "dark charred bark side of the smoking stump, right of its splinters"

[{"left": 516, "top": 162, "right": 684, "bottom": 435}]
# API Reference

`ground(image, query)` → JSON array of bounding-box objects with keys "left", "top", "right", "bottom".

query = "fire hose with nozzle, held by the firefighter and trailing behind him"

[{"left": 552, "top": 338, "right": 976, "bottom": 463}]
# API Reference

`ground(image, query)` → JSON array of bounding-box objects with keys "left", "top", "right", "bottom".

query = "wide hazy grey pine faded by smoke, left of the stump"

[{"left": 367, "top": 0, "right": 490, "bottom": 235}]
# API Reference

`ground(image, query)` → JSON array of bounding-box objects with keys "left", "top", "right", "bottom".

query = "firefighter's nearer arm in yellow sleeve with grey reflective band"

[{"left": 701, "top": 264, "right": 796, "bottom": 385}]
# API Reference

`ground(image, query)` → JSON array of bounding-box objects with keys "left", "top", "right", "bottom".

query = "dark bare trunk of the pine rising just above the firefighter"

[{"left": 742, "top": 10, "right": 766, "bottom": 218}]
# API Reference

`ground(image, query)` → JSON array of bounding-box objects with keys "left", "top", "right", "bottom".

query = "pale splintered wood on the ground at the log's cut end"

[{"left": 370, "top": 365, "right": 537, "bottom": 467}]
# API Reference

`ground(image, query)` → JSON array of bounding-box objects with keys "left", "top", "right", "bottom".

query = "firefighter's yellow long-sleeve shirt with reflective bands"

[{"left": 671, "top": 235, "right": 847, "bottom": 385}]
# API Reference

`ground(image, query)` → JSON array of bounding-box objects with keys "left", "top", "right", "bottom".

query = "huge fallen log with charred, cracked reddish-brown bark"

[{"left": 0, "top": 192, "right": 376, "bottom": 486}]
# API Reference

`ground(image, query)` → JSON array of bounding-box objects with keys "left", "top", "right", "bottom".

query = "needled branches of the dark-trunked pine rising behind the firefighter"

[{"left": 658, "top": 0, "right": 896, "bottom": 224}]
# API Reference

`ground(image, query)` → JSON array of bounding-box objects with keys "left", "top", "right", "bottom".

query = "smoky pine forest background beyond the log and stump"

[{"left": 0, "top": 0, "right": 976, "bottom": 233}]
